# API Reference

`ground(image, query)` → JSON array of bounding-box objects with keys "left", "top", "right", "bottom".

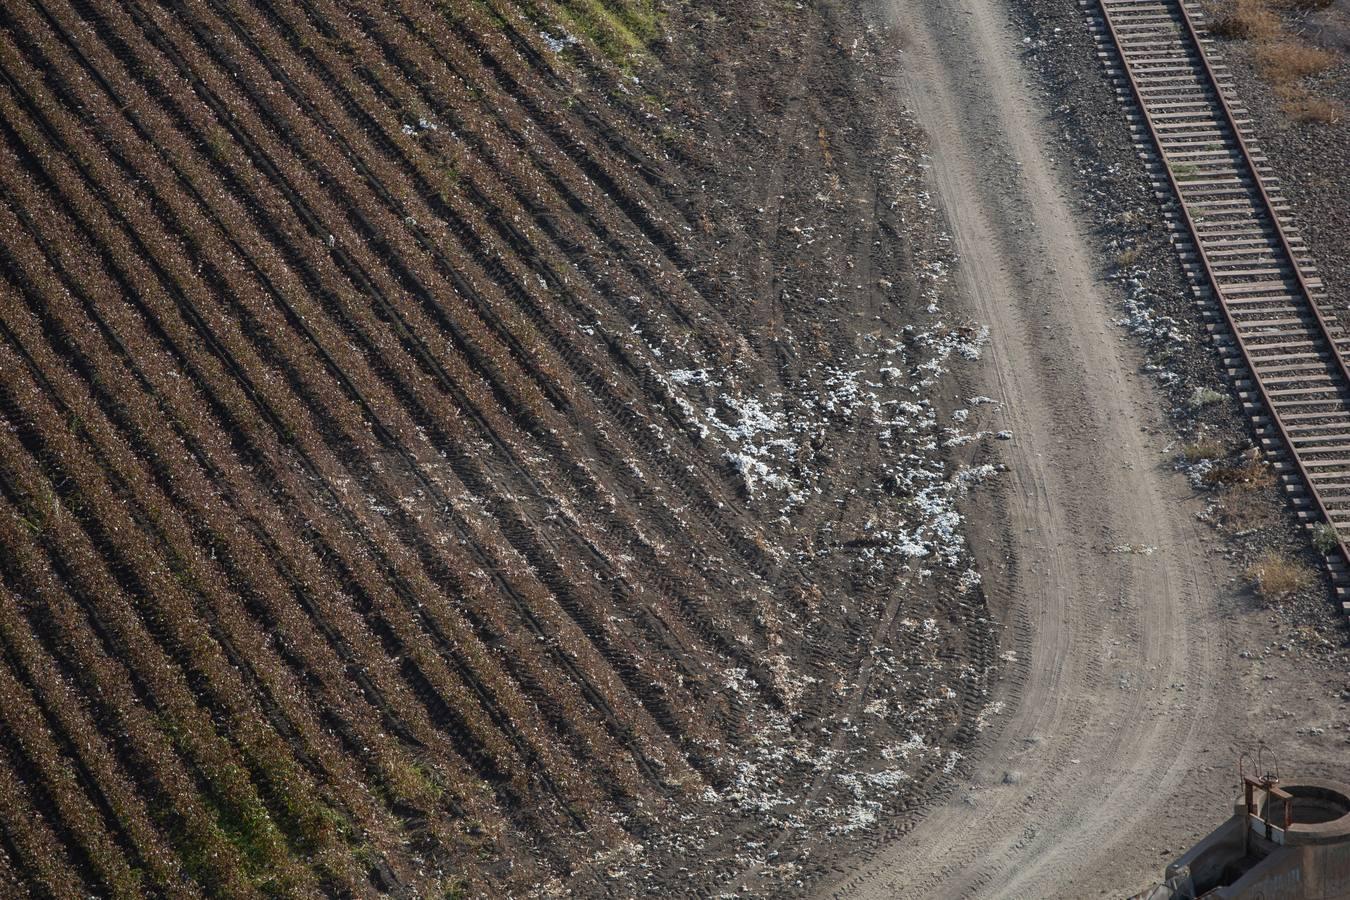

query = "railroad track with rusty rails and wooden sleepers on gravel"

[{"left": 1080, "top": 0, "right": 1350, "bottom": 614}]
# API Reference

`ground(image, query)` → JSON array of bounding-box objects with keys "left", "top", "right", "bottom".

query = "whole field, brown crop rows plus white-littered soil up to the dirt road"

[{"left": 0, "top": 0, "right": 996, "bottom": 896}]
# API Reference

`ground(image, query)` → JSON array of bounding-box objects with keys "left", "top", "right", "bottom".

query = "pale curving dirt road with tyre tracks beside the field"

[{"left": 825, "top": 0, "right": 1233, "bottom": 897}]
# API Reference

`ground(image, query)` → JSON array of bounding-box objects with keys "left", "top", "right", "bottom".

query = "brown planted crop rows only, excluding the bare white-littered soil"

[{"left": 0, "top": 0, "right": 820, "bottom": 896}]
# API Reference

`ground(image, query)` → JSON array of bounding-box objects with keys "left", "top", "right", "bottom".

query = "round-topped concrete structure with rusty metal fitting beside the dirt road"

[{"left": 1137, "top": 777, "right": 1350, "bottom": 900}]
